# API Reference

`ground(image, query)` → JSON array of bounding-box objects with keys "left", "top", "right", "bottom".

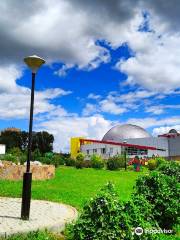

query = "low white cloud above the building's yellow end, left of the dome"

[{"left": 35, "top": 115, "right": 113, "bottom": 152}]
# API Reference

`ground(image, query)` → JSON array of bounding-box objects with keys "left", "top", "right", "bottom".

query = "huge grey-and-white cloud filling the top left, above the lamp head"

[{"left": 0, "top": 0, "right": 140, "bottom": 70}]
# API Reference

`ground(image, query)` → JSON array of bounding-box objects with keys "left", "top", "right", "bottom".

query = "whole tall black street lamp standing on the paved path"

[{"left": 21, "top": 55, "right": 45, "bottom": 220}]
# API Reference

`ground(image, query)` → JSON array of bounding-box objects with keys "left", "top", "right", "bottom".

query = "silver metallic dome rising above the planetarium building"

[{"left": 102, "top": 124, "right": 152, "bottom": 142}]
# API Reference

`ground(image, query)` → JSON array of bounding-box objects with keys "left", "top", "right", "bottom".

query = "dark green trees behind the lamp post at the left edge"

[{"left": 0, "top": 130, "right": 54, "bottom": 155}]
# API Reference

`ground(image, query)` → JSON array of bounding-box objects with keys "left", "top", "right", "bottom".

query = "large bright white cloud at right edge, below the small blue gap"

[{"left": 116, "top": 25, "right": 180, "bottom": 92}]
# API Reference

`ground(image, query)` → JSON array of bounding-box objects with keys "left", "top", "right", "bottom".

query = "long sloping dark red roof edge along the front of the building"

[{"left": 80, "top": 139, "right": 164, "bottom": 151}]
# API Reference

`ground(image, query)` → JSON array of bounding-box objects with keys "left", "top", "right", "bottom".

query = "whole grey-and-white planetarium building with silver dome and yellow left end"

[{"left": 71, "top": 124, "right": 180, "bottom": 159}]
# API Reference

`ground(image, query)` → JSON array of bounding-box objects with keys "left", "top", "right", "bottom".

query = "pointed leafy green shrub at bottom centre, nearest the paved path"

[{"left": 68, "top": 184, "right": 127, "bottom": 240}]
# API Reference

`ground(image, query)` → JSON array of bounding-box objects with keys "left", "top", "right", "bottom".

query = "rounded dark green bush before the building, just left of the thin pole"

[{"left": 107, "top": 155, "right": 125, "bottom": 170}]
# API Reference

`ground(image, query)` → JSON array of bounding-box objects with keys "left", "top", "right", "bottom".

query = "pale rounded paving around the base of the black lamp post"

[{"left": 0, "top": 197, "right": 78, "bottom": 236}]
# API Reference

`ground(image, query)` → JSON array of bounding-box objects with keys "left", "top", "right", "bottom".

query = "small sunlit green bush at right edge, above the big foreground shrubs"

[{"left": 157, "top": 161, "right": 180, "bottom": 182}]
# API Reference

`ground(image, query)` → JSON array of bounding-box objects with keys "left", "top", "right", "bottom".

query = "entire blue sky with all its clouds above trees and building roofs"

[{"left": 0, "top": 0, "right": 180, "bottom": 152}]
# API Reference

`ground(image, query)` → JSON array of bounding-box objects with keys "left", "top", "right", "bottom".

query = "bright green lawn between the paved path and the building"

[{"left": 0, "top": 166, "right": 145, "bottom": 209}]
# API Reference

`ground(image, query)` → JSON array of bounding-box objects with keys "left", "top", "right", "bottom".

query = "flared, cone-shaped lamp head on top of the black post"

[{"left": 24, "top": 55, "right": 45, "bottom": 73}]
